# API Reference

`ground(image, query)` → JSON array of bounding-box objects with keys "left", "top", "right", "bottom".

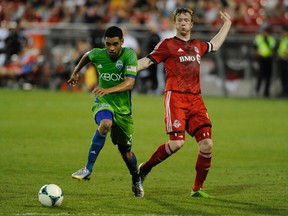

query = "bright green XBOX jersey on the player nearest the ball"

[{"left": 88, "top": 47, "right": 138, "bottom": 115}]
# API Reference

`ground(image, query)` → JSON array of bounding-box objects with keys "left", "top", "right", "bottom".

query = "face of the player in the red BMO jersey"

[{"left": 175, "top": 13, "right": 193, "bottom": 36}]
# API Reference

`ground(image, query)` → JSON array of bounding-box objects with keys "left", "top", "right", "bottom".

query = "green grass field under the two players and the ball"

[{"left": 0, "top": 89, "right": 288, "bottom": 216}]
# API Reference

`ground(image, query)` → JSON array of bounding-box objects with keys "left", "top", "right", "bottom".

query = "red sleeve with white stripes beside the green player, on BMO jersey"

[{"left": 147, "top": 39, "right": 170, "bottom": 63}]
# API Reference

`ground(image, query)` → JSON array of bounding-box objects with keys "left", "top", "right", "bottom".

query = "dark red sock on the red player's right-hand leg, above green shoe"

[{"left": 193, "top": 152, "right": 212, "bottom": 191}]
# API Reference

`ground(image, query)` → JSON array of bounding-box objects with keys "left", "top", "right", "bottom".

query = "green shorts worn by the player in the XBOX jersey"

[{"left": 92, "top": 103, "right": 134, "bottom": 148}]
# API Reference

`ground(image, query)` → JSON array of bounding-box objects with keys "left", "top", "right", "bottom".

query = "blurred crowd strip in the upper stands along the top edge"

[{"left": 0, "top": 0, "right": 288, "bottom": 28}]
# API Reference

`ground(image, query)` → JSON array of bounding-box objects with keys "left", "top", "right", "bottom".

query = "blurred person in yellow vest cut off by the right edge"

[{"left": 277, "top": 26, "right": 288, "bottom": 97}]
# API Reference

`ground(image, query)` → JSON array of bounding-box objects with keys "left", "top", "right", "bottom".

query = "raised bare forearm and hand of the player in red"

[{"left": 210, "top": 11, "right": 232, "bottom": 51}]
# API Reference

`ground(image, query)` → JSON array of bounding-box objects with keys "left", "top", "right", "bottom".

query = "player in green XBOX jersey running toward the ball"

[{"left": 68, "top": 26, "right": 144, "bottom": 197}]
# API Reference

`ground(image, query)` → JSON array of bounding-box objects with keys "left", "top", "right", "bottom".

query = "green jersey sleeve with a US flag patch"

[{"left": 125, "top": 48, "right": 138, "bottom": 78}]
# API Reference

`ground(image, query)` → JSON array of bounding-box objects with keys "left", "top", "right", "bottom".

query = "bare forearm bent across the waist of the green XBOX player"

[{"left": 92, "top": 76, "right": 135, "bottom": 97}]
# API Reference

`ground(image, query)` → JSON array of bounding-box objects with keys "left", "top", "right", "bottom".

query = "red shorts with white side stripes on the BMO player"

[{"left": 164, "top": 91, "right": 212, "bottom": 140}]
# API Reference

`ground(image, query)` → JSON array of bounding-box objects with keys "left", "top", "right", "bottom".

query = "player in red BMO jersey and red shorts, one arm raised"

[{"left": 138, "top": 8, "right": 231, "bottom": 198}]
